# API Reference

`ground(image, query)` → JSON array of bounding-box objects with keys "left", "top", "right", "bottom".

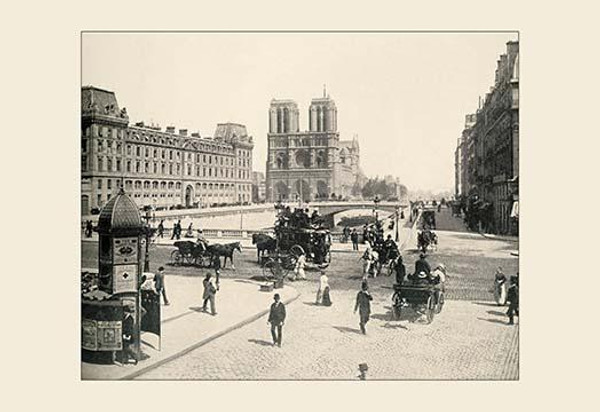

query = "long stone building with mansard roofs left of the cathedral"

[{"left": 81, "top": 86, "right": 254, "bottom": 214}]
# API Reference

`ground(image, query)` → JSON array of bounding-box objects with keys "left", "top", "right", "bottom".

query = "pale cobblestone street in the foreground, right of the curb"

[{"left": 130, "top": 212, "right": 518, "bottom": 380}]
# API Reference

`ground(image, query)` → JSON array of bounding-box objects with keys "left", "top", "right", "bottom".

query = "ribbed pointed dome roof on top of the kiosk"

[{"left": 98, "top": 188, "right": 142, "bottom": 233}]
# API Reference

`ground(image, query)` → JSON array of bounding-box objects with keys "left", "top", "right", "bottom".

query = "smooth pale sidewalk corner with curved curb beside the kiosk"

[{"left": 81, "top": 276, "right": 299, "bottom": 380}]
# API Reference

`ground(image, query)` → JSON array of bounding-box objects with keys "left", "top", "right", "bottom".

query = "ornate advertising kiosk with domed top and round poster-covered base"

[{"left": 81, "top": 188, "right": 144, "bottom": 363}]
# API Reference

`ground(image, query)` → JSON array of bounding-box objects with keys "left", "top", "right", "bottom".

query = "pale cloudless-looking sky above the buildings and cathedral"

[{"left": 82, "top": 33, "right": 517, "bottom": 191}]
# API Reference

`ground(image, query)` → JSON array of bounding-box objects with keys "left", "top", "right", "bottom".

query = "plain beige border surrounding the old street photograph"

[{"left": 2, "top": 0, "right": 598, "bottom": 412}]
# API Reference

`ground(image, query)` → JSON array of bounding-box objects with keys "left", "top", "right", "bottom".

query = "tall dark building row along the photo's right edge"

[{"left": 456, "top": 41, "right": 519, "bottom": 234}]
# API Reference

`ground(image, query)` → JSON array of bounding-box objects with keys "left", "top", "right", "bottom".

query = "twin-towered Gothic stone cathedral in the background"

[{"left": 266, "top": 90, "right": 360, "bottom": 202}]
